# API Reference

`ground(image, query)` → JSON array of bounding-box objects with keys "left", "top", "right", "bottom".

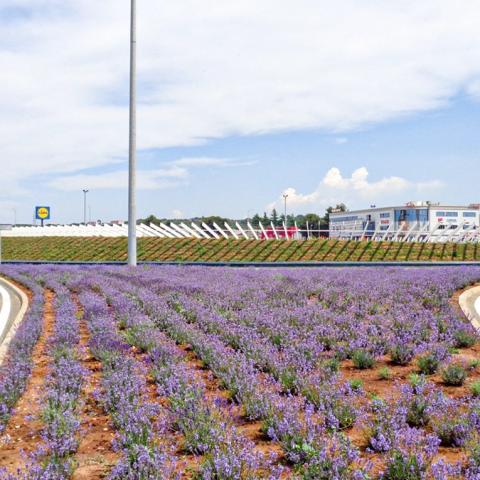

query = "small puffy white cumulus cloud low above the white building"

[{"left": 267, "top": 167, "right": 443, "bottom": 213}]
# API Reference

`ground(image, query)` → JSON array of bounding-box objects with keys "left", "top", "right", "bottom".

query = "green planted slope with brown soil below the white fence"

[{"left": 2, "top": 237, "right": 480, "bottom": 262}]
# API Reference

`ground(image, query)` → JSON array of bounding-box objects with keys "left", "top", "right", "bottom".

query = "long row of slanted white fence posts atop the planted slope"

[{"left": 2, "top": 222, "right": 480, "bottom": 243}]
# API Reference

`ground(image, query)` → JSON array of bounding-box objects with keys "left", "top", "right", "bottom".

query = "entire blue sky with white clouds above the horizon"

[{"left": 0, "top": 0, "right": 480, "bottom": 222}]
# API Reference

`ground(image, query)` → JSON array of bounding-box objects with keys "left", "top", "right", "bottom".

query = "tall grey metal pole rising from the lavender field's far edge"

[{"left": 128, "top": 0, "right": 137, "bottom": 266}]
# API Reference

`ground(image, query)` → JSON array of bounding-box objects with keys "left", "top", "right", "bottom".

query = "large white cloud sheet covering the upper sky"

[{"left": 0, "top": 0, "right": 480, "bottom": 194}]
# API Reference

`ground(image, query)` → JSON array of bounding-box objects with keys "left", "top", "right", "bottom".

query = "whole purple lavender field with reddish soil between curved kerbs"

[{"left": 0, "top": 266, "right": 480, "bottom": 480}]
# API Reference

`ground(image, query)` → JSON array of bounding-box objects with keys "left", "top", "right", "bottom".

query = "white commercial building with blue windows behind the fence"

[{"left": 329, "top": 202, "right": 480, "bottom": 241}]
